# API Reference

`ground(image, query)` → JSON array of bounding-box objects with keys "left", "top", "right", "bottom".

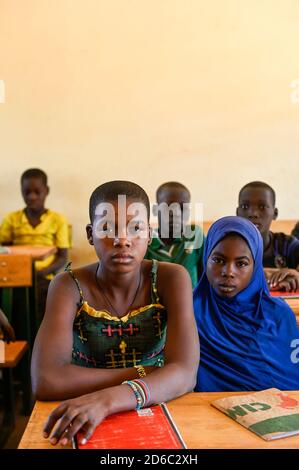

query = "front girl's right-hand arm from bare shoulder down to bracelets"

[{"left": 143, "top": 263, "right": 199, "bottom": 403}]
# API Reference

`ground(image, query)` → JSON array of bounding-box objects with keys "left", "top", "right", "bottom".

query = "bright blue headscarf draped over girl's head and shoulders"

[{"left": 193, "top": 217, "right": 299, "bottom": 391}]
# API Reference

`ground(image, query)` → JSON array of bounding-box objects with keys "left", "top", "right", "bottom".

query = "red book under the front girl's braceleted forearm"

[{"left": 75, "top": 403, "right": 186, "bottom": 449}]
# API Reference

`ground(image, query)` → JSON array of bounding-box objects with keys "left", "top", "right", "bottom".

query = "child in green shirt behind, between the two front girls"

[{"left": 145, "top": 182, "right": 204, "bottom": 287}]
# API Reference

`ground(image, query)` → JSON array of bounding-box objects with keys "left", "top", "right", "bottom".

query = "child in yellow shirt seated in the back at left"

[{"left": 0, "top": 168, "right": 69, "bottom": 318}]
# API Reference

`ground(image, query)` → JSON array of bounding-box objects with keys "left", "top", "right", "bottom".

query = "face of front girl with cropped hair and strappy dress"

[{"left": 86, "top": 200, "right": 150, "bottom": 273}]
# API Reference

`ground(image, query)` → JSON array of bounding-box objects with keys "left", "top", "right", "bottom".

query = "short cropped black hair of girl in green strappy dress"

[{"left": 89, "top": 180, "right": 150, "bottom": 223}]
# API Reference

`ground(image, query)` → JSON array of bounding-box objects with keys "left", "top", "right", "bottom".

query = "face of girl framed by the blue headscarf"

[{"left": 206, "top": 234, "right": 254, "bottom": 298}]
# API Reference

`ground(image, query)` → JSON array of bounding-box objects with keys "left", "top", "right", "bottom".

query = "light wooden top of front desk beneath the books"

[{"left": 18, "top": 391, "right": 299, "bottom": 450}]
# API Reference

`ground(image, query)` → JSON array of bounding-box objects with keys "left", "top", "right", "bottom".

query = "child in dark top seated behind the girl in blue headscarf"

[{"left": 237, "top": 181, "right": 299, "bottom": 292}]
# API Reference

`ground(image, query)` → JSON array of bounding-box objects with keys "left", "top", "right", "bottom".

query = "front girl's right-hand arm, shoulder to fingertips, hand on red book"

[{"left": 44, "top": 263, "right": 199, "bottom": 444}]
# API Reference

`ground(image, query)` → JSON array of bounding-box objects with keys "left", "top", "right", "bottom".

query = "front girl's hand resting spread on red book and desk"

[{"left": 43, "top": 389, "right": 110, "bottom": 445}]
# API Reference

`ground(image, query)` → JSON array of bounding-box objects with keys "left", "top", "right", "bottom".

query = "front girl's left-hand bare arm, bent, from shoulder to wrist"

[{"left": 31, "top": 273, "right": 152, "bottom": 400}]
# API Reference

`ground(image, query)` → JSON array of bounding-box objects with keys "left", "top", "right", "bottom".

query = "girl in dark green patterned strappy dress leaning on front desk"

[{"left": 32, "top": 181, "right": 199, "bottom": 445}]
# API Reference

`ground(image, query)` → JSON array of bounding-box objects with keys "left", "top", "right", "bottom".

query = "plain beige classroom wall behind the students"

[{"left": 0, "top": 0, "right": 299, "bottom": 263}]
